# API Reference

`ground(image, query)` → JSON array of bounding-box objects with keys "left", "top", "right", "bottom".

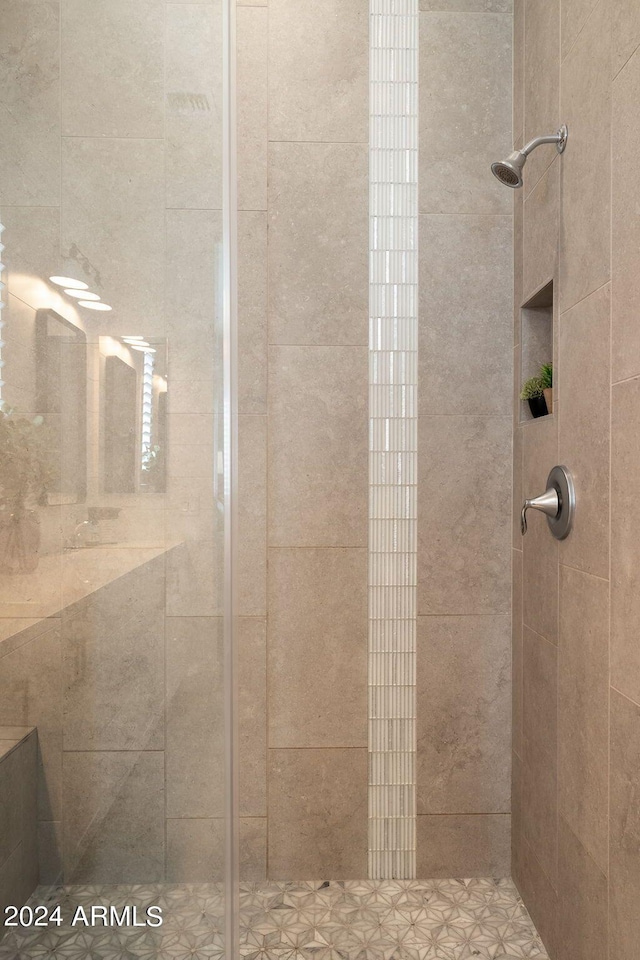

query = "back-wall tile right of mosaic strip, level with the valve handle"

[{"left": 418, "top": 416, "right": 511, "bottom": 615}]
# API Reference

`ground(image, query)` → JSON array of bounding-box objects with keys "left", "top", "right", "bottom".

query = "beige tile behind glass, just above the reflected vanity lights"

[{"left": 61, "top": 138, "right": 165, "bottom": 335}]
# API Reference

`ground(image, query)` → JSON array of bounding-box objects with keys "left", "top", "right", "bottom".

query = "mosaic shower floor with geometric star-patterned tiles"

[{"left": 0, "top": 879, "right": 547, "bottom": 960}]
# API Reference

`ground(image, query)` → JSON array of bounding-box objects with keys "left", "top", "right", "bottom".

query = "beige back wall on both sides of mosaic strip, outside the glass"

[{"left": 238, "top": 0, "right": 512, "bottom": 879}]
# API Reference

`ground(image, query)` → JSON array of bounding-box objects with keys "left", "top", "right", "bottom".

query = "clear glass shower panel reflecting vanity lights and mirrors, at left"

[{"left": 0, "top": 0, "right": 232, "bottom": 958}]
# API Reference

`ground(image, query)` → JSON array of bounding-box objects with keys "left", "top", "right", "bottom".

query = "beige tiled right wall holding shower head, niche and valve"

[{"left": 513, "top": 0, "right": 640, "bottom": 960}]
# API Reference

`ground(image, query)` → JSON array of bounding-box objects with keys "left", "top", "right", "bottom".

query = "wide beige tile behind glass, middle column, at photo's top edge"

[{"left": 60, "top": 0, "right": 165, "bottom": 138}]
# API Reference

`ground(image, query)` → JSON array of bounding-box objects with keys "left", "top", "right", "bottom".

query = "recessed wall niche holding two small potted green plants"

[{"left": 520, "top": 280, "right": 554, "bottom": 423}]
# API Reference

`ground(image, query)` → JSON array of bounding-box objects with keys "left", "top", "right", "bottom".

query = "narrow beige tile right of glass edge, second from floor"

[{"left": 237, "top": 617, "right": 267, "bottom": 818}]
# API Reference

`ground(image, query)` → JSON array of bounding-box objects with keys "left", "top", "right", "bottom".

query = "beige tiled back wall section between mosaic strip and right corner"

[{"left": 417, "top": 0, "right": 512, "bottom": 877}]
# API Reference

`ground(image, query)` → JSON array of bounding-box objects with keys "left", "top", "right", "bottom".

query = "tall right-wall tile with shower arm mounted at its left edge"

[{"left": 559, "top": 0, "right": 611, "bottom": 312}]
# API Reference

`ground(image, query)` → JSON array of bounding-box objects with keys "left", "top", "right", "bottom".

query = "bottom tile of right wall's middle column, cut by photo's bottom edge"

[{"left": 558, "top": 817, "right": 609, "bottom": 960}]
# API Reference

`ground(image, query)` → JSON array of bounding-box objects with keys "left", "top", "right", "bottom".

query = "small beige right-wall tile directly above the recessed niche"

[{"left": 522, "top": 154, "right": 560, "bottom": 302}]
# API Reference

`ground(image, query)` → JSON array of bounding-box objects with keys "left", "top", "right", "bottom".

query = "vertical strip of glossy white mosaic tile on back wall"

[{"left": 369, "top": 0, "right": 419, "bottom": 879}]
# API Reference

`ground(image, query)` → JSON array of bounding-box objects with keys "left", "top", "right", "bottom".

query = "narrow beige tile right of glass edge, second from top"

[{"left": 238, "top": 211, "right": 267, "bottom": 414}]
